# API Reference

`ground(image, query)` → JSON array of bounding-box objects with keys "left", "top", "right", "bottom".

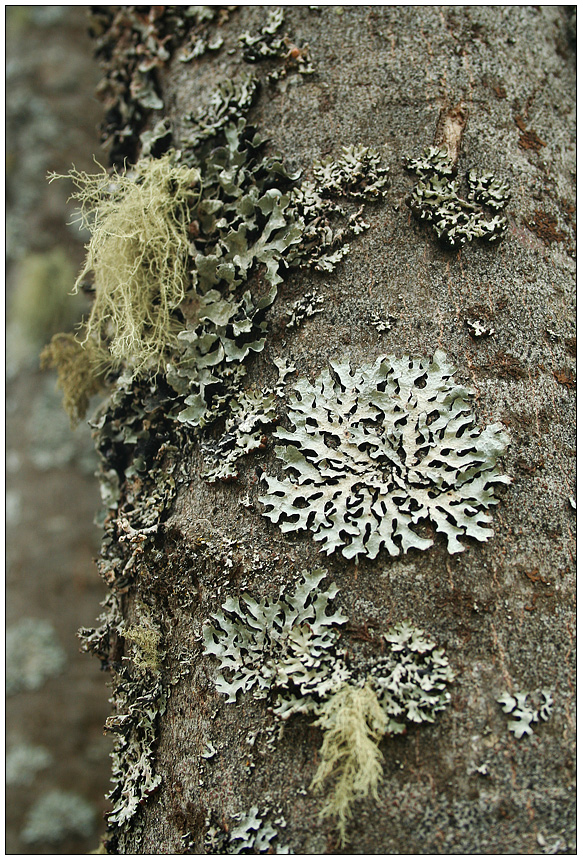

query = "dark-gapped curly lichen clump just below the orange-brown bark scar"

[{"left": 405, "top": 147, "right": 510, "bottom": 248}]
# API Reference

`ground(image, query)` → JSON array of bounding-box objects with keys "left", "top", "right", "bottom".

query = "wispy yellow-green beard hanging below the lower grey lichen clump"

[{"left": 311, "top": 682, "right": 387, "bottom": 844}]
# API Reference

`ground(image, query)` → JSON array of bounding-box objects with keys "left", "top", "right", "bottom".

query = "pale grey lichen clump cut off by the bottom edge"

[{"left": 204, "top": 806, "right": 291, "bottom": 855}]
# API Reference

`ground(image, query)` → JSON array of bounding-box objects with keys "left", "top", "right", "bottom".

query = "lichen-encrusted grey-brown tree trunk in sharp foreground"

[{"left": 75, "top": 6, "right": 575, "bottom": 854}]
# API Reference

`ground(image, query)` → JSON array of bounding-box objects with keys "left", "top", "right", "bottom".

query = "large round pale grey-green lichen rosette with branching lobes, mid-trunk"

[{"left": 260, "top": 351, "right": 510, "bottom": 559}]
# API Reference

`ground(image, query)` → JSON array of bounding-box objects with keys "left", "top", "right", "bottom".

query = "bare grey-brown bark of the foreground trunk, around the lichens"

[{"left": 80, "top": 6, "right": 575, "bottom": 854}]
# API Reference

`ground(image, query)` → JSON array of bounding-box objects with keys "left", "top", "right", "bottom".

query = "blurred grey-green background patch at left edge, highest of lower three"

[{"left": 6, "top": 619, "right": 66, "bottom": 694}]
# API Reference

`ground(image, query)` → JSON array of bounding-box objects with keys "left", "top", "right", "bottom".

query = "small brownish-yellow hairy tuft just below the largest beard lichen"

[{"left": 40, "top": 333, "right": 101, "bottom": 427}]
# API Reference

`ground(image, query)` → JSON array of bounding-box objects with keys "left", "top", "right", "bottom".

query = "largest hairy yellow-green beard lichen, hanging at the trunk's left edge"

[{"left": 51, "top": 154, "right": 200, "bottom": 371}]
